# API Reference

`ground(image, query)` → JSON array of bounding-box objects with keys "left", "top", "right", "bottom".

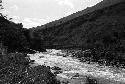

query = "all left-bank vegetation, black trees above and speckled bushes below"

[{"left": 0, "top": 15, "right": 60, "bottom": 84}]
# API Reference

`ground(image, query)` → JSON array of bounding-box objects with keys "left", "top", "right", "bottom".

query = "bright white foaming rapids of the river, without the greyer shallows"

[{"left": 29, "top": 49, "right": 125, "bottom": 83}]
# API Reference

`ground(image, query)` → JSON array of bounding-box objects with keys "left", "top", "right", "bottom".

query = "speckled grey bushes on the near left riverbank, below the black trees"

[{"left": 0, "top": 53, "right": 59, "bottom": 84}]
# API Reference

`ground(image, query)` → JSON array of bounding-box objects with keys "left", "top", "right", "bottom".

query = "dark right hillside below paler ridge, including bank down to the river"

[{"left": 32, "top": 2, "right": 125, "bottom": 67}]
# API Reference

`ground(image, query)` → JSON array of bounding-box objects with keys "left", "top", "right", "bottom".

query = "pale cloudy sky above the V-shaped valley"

[{"left": 3, "top": 0, "right": 102, "bottom": 28}]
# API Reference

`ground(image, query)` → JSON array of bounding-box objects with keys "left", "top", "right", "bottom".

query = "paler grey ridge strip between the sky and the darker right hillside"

[{"left": 34, "top": 0, "right": 124, "bottom": 29}]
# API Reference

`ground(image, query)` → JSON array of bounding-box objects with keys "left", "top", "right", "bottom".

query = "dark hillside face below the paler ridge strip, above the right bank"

[{"left": 32, "top": 2, "right": 125, "bottom": 46}]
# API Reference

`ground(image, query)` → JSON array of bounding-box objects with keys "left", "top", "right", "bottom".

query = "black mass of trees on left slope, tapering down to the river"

[{"left": 0, "top": 14, "right": 45, "bottom": 53}]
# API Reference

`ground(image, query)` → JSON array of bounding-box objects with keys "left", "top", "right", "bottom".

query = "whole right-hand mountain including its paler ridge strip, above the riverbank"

[{"left": 30, "top": 0, "right": 125, "bottom": 47}]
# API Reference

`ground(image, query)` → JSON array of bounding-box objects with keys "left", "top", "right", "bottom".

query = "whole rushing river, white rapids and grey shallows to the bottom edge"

[{"left": 28, "top": 49, "right": 125, "bottom": 84}]
